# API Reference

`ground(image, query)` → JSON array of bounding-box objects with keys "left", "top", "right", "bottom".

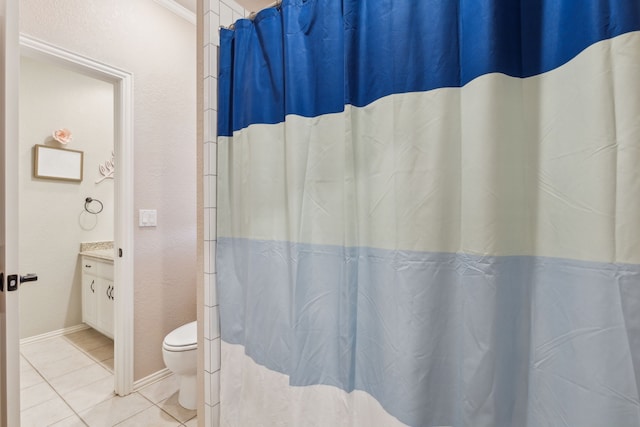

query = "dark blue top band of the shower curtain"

[{"left": 218, "top": 0, "right": 640, "bottom": 136}]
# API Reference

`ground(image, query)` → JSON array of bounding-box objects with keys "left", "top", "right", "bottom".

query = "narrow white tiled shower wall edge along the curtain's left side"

[{"left": 203, "top": 0, "right": 249, "bottom": 427}]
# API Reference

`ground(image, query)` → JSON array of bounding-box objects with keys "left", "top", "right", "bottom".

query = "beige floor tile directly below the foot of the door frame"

[{"left": 80, "top": 393, "right": 153, "bottom": 427}]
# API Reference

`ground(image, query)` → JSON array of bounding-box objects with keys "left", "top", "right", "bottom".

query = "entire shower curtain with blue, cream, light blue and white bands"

[{"left": 216, "top": 0, "right": 640, "bottom": 427}]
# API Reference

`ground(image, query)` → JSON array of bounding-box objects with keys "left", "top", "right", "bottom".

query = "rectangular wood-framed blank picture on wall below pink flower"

[{"left": 33, "top": 144, "right": 84, "bottom": 182}]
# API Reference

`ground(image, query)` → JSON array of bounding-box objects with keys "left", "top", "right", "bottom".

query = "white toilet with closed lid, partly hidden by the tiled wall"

[{"left": 162, "top": 321, "right": 198, "bottom": 409}]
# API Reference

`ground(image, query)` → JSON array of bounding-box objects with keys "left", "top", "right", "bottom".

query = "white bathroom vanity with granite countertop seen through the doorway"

[{"left": 80, "top": 242, "right": 116, "bottom": 338}]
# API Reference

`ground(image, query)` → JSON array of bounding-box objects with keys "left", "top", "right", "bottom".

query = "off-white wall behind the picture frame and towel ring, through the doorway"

[{"left": 18, "top": 57, "right": 114, "bottom": 338}]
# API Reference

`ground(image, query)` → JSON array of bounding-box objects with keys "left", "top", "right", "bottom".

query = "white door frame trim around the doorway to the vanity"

[{"left": 20, "top": 34, "right": 134, "bottom": 396}]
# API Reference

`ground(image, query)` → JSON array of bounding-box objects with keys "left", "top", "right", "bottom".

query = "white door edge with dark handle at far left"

[{"left": 0, "top": 0, "right": 20, "bottom": 427}]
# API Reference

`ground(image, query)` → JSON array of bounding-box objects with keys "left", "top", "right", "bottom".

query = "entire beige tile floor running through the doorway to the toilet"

[{"left": 20, "top": 329, "right": 198, "bottom": 427}]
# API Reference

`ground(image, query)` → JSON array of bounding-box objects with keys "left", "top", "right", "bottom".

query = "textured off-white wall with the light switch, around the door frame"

[{"left": 20, "top": 0, "right": 197, "bottom": 380}]
